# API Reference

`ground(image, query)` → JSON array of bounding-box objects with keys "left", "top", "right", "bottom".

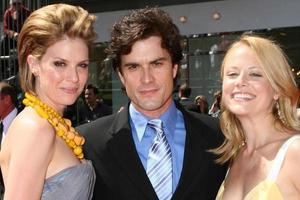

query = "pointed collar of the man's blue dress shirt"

[{"left": 129, "top": 101, "right": 177, "bottom": 141}]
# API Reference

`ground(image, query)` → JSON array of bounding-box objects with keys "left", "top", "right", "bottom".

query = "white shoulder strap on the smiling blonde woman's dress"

[{"left": 267, "top": 134, "right": 300, "bottom": 182}]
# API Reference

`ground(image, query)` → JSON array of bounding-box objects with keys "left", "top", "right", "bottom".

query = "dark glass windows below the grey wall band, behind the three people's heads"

[{"left": 84, "top": 27, "right": 300, "bottom": 117}]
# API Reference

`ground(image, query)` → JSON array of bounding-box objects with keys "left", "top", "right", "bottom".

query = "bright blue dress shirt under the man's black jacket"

[{"left": 129, "top": 102, "right": 186, "bottom": 193}]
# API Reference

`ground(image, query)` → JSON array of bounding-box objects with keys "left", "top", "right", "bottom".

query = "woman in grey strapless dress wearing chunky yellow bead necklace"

[{"left": 0, "top": 4, "right": 96, "bottom": 200}]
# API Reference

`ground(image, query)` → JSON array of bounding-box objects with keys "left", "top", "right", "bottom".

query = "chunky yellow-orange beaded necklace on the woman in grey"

[{"left": 23, "top": 92, "right": 85, "bottom": 159}]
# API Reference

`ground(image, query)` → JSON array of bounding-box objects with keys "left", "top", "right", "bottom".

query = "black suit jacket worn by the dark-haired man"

[{"left": 78, "top": 102, "right": 226, "bottom": 200}]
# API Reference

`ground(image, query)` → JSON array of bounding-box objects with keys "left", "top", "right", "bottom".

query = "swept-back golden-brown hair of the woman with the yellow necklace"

[{"left": 18, "top": 4, "right": 96, "bottom": 93}]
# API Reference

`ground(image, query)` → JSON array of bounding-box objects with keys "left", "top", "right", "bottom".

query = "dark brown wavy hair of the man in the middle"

[{"left": 106, "top": 7, "right": 182, "bottom": 72}]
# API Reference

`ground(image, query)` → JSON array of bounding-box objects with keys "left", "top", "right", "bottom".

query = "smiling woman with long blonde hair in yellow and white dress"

[{"left": 216, "top": 35, "right": 300, "bottom": 200}]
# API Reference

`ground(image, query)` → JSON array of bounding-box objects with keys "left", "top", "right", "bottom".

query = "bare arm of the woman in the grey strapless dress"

[{"left": 4, "top": 118, "right": 55, "bottom": 200}]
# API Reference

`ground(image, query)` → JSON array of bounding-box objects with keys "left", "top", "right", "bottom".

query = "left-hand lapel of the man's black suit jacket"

[{"left": 109, "top": 107, "right": 157, "bottom": 199}]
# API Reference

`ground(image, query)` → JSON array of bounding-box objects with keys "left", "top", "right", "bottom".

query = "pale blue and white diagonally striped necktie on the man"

[{"left": 147, "top": 119, "right": 172, "bottom": 200}]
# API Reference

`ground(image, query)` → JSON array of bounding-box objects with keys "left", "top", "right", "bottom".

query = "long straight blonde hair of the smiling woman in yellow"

[{"left": 212, "top": 34, "right": 300, "bottom": 163}]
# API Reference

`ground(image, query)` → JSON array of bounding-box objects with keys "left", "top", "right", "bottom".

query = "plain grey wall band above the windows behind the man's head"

[{"left": 95, "top": 0, "right": 300, "bottom": 42}]
